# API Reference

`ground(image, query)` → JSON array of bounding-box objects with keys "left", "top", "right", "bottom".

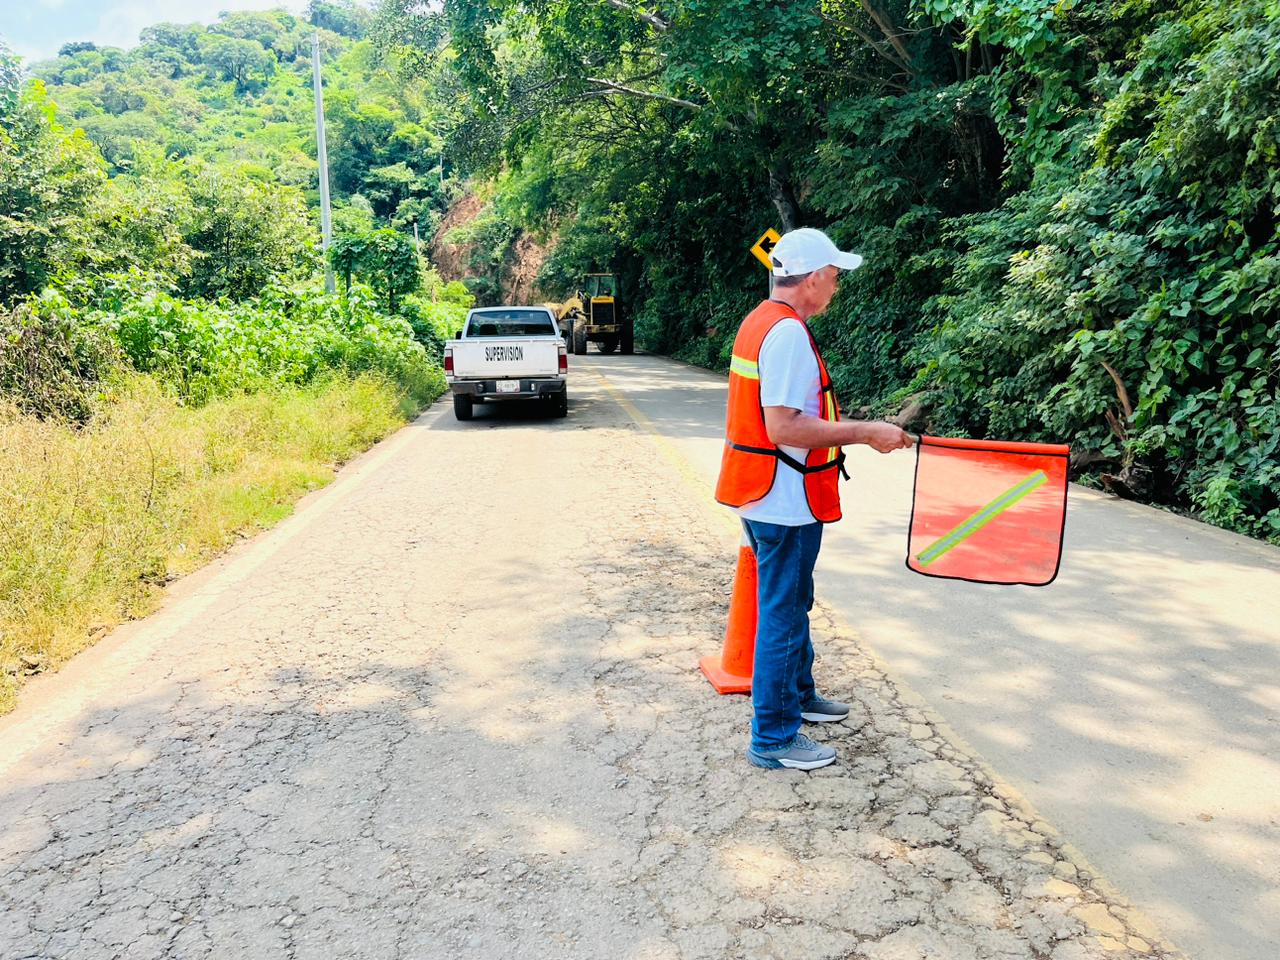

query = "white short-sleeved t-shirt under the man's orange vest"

[{"left": 733, "top": 317, "right": 819, "bottom": 526}]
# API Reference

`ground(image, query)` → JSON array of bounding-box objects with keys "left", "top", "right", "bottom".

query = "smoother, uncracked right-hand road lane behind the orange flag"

[{"left": 586, "top": 356, "right": 1280, "bottom": 960}]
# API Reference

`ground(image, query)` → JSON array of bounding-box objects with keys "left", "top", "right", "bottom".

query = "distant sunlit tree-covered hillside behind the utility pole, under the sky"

[{"left": 0, "top": 3, "right": 471, "bottom": 301}]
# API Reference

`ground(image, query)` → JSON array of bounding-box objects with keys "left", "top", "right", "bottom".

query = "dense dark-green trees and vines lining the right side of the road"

[{"left": 374, "top": 0, "right": 1280, "bottom": 541}]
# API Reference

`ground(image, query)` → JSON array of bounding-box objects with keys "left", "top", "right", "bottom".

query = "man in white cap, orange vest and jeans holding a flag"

[{"left": 716, "top": 229, "right": 913, "bottom": 771}]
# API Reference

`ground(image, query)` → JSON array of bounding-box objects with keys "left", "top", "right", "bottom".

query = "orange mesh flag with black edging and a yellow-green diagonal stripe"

[{"left": 906, "top": 436, "right": 1071, "bottom": 586}]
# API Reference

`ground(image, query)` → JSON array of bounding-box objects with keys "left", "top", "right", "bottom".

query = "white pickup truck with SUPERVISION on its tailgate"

[{"left": 444, "top": 307, "right": 568, "bottom": 420}]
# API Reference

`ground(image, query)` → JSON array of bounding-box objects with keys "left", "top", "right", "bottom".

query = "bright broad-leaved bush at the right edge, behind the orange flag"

[{"left": 920, "top": 3, "right": 1280, "bottom": 543}]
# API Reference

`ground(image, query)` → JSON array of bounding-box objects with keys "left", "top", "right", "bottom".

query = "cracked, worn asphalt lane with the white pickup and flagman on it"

[{"left": 0, "top": 369, "right": 1179, "bottom": 960}]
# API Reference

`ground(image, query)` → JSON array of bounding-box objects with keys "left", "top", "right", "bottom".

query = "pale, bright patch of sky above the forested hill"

[{"left": 0, "top": 0, "right": 306, "bottom": 63}]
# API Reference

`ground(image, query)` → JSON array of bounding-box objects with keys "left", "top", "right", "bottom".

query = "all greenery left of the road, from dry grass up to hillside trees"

[{"left": 0, "top": 0, "right": 472, "bottom": 710}]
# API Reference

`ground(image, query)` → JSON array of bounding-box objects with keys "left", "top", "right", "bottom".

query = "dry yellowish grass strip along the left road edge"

[{"left": 0, "top": 375, "right": 411, "bottom": 713}]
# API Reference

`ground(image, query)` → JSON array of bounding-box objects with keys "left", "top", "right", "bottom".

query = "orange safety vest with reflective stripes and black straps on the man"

[{"left": 716, "top": 300, "right": 849, "bottom": 524}]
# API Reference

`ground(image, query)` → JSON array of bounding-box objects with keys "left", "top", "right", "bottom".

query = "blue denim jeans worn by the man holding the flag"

[{"left": 742, "top": 520, "right": 822, "bottom": 750}]
